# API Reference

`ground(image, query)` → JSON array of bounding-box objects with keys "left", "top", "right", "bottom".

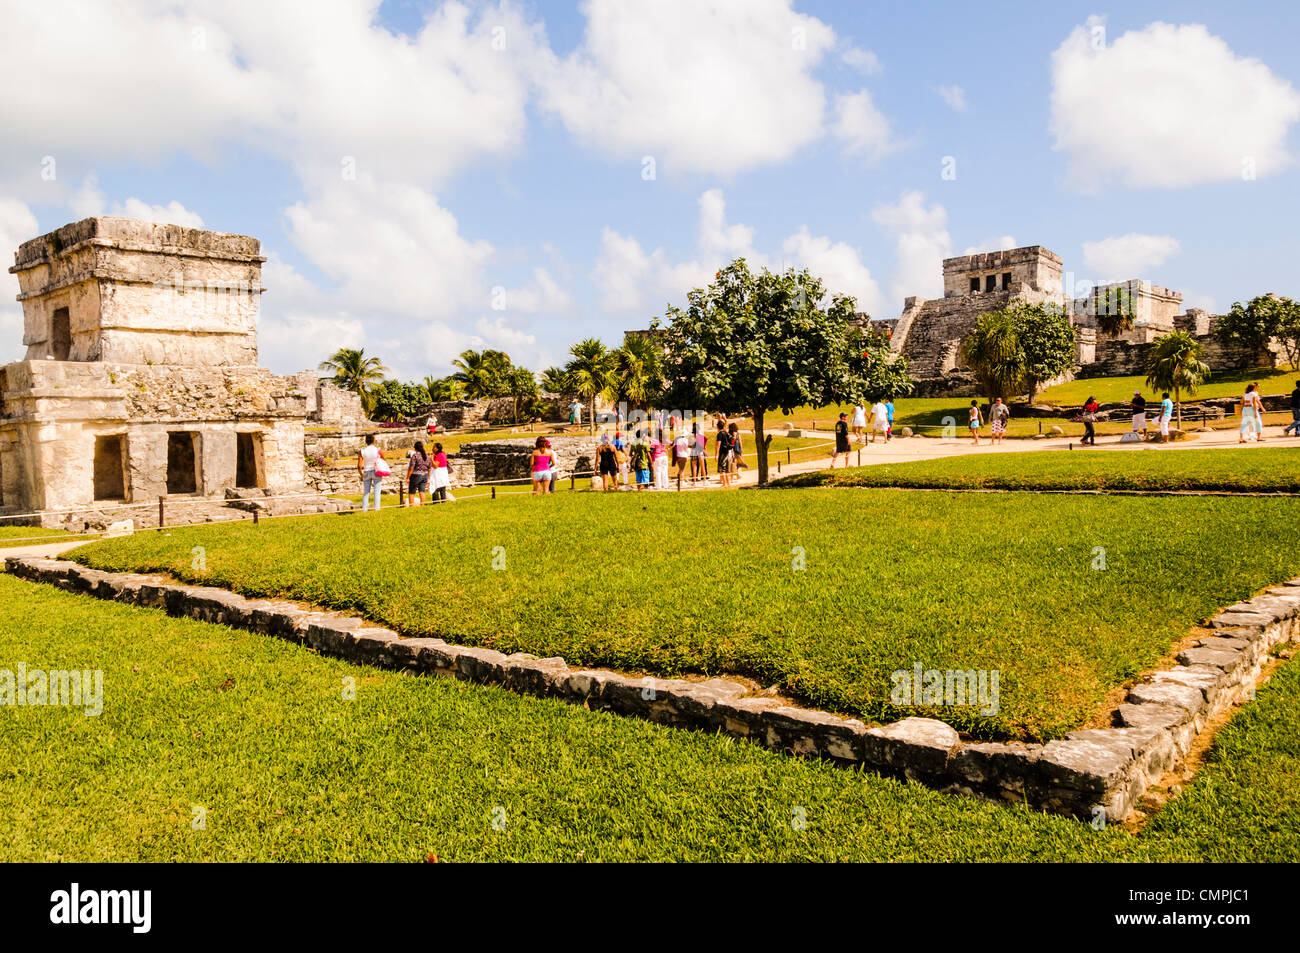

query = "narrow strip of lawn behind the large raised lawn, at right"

[{"left": 775, "top": 446, "right": 1300, "bottom": 491}]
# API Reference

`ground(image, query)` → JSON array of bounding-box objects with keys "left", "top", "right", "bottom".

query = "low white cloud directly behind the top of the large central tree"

[{"left": 592, "top": 189, "right": 883, "bottom": 317}]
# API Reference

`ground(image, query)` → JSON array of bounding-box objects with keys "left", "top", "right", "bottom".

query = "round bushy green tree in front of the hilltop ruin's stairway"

[{"left": 962, "top": 302, "right": 1075, "bottom": 402}]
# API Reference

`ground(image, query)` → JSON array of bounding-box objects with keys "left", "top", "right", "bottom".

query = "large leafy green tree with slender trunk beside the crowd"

[{"left": 654, "top": 259, "right": 911, "bottom": 484}]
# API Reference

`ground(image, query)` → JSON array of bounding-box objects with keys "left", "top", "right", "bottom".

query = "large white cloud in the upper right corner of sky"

[{"left": 1050, "top": 17, "right": 1300, "bottom": 190}]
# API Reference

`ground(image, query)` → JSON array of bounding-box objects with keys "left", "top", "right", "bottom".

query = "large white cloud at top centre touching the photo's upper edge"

[{"left": 540, "top": 0, "right": 837, "bottom": 174}]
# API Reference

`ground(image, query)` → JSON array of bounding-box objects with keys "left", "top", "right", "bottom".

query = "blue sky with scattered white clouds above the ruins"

[{"left": 0, "top": 0, "right": 1300, "bottom": 377}]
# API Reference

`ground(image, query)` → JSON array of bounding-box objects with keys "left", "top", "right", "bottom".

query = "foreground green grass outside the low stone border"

[{"left": 0, "top": 576, "right": 1300, "bottom": 862}]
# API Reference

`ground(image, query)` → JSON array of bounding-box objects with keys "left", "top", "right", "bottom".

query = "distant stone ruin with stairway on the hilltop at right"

[{"left": 871, "top": 244, "right": 1256, "bottom": 397}]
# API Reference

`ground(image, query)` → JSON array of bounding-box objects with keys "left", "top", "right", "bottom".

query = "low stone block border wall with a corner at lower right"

[{"left": 5, "top": 556, "right": 1300, "bottom": 823}]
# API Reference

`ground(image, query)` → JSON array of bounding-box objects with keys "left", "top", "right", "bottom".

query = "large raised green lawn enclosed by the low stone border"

[{"left": 73, "top": 489, "right": 1300, "bottom": 738}]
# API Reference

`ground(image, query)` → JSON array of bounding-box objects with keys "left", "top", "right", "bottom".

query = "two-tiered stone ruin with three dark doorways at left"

[{"left": 0, "top": 217, "right": 340, "bottom": 529}]
